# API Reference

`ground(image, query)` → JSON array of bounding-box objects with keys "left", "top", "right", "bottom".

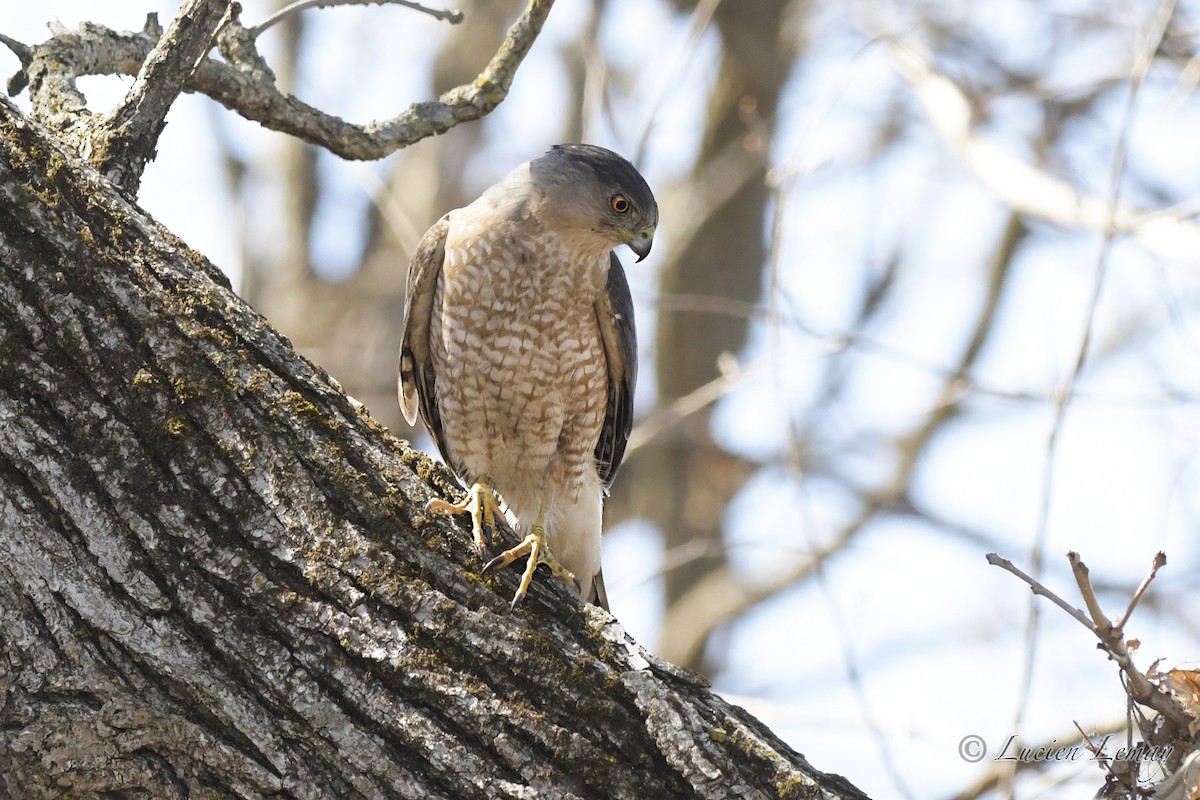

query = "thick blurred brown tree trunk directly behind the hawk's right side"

[{"left": 643, "top": 0, "right": 805, "bottom": 670}]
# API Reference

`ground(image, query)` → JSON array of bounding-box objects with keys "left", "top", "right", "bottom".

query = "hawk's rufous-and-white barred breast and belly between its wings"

[{"left": 431, "top": 212, "right": 607, "bottom": 573}]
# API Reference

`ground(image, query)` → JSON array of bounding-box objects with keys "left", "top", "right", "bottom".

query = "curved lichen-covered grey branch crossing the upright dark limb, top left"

[{"left": 10, "top": 0, "right": 554, "bottom": 160}]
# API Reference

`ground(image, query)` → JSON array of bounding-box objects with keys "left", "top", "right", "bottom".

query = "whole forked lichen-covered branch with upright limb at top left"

[{"left": 4, "top": 0, "right": 554, "bottom": 179}]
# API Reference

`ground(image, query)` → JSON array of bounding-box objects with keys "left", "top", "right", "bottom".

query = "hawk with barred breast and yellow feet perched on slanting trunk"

[{"left": 400, "top": 145, "right": 659, "bottom": 607}]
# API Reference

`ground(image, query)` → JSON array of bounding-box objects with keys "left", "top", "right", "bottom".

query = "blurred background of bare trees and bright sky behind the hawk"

[{"left": 6, "top": 0, "right": 1200, "bottom": 798}]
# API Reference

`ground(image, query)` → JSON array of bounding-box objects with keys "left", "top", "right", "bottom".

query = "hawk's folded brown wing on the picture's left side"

[{"left": 397, "top": 213, "right": 450, "bottom": 463}]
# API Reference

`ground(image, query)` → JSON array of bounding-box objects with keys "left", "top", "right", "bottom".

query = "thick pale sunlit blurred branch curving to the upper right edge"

[{"left": 884, "top": 38, "right": 1200, "bottom": 265}]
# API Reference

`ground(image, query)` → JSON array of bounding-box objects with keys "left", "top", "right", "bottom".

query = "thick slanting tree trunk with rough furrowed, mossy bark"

[{"left": 0, "top": 101, "right": 863, "bottom": 799}]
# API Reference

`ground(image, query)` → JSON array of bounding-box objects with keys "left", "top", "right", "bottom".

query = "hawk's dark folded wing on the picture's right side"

[{"left": 595, "top": 253, "right": 637, "bottom": 488}]
